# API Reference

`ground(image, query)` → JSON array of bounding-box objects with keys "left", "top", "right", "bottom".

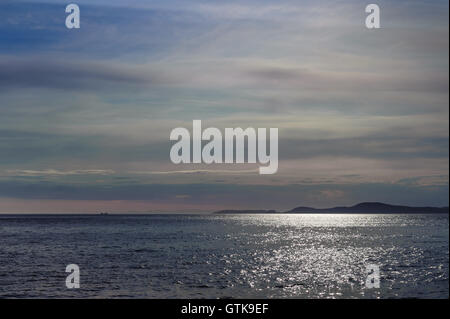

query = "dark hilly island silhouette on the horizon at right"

[{"left": 213, "top": 202, "right": 449, "bottom": 214}]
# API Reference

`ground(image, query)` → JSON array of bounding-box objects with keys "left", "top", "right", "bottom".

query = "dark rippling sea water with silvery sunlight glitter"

[{"left": 0, "top": 214, "right": 449, "bottom": 298}]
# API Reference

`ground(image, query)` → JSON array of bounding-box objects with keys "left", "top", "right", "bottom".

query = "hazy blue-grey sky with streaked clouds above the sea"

[{"left": 0, "top": 0, "right": 449, "bottom": 213}]
